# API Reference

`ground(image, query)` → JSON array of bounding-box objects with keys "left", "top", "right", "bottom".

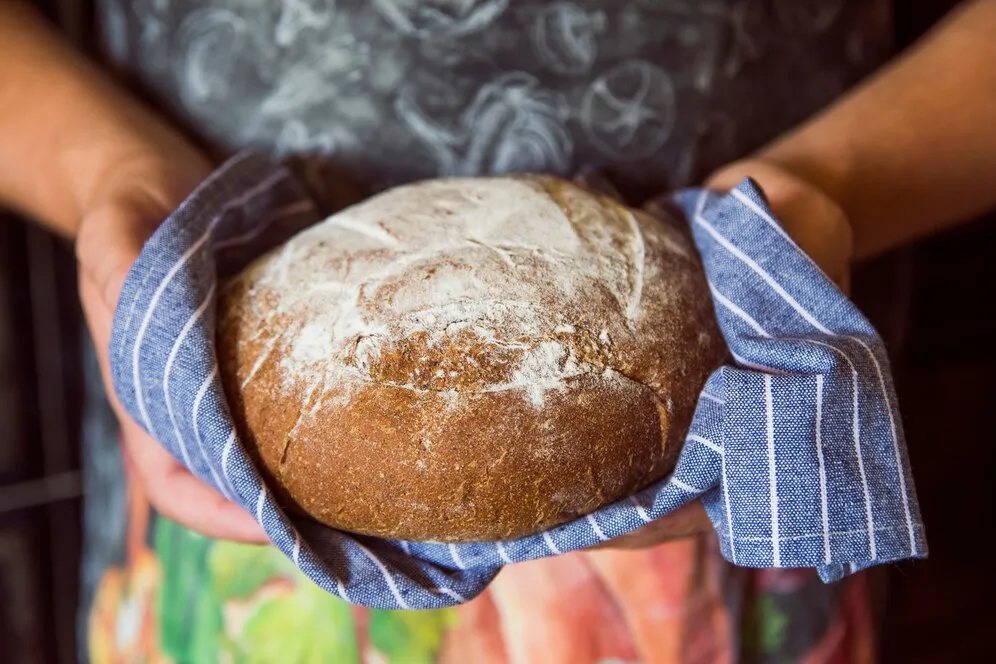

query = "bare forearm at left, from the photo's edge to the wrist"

[{"left": 0, "top": 0, "right": 206, "bottom": 237}]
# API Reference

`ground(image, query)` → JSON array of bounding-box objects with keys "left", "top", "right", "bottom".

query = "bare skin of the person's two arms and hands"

[{"left": 0, "top": 0, "right": 996, "bottom": 547}]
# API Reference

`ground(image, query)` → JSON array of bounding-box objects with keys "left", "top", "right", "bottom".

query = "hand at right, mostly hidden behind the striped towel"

[{"left": 593, "top": 159, "right": 854, "bottom": 549}]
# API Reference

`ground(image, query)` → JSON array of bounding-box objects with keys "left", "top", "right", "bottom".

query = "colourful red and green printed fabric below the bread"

[{"left": 86, "top": 456, "right": 874, "bottom": 664}]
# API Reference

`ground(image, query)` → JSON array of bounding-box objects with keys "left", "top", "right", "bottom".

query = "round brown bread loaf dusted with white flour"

[{"left": 218, "top": 176, "right": 726, "bottom": 542}]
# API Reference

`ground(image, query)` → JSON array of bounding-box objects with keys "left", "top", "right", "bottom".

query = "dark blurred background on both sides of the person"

[{"left": 0, "top": 0, "right": 996, "bottom": 664}]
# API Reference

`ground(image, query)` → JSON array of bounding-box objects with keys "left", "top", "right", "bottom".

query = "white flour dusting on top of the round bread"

[{"left": 227, "top": 178, "right": 682, "bottom": 407}]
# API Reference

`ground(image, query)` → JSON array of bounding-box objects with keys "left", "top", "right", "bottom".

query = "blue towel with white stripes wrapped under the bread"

[{"left": 111, "top": 153, "right": 926, "bottom": 609}]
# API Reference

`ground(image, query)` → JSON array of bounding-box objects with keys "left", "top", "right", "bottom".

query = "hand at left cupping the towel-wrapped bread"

[{"left": 76, "top": 146, "right": 267, "bottom": 543}]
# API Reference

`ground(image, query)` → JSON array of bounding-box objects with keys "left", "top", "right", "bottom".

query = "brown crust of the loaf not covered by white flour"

[{"left": 218, "top": 178, "right": 725, "bottom": 542}]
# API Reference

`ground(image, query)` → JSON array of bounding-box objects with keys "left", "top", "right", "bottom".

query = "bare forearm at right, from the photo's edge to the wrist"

[{"left": 720, "top": 0, "right": 996, "bottom": 259}]
